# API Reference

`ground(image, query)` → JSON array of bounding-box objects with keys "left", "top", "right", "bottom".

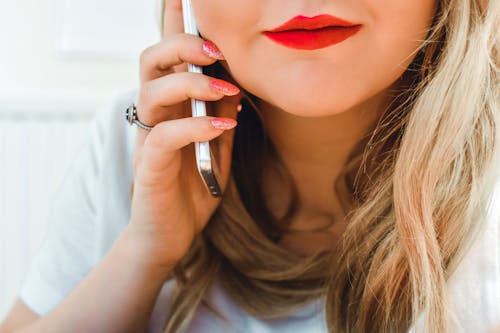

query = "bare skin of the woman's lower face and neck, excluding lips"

[{"left": 192, "top": 0, "right": 436, "bottom": 252}]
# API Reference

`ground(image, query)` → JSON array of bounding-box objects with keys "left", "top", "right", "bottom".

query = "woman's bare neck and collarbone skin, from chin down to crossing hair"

[{"left": 257, "top": 88, "right": 392, "bottom": 254}]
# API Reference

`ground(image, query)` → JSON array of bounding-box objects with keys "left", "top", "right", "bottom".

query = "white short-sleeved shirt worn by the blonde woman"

[{"left": 20, "top": 90, "right": 500, "bottom": 333}]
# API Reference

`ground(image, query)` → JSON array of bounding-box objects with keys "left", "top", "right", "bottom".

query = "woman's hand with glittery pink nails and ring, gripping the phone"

[{"left": 126, "top": 1, "right": 240, "bottom": 267}]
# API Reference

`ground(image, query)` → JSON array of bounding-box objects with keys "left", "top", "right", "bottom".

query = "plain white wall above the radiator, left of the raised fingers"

[{"left": 0, "top": 0, "right": 158, "bottom": 108}]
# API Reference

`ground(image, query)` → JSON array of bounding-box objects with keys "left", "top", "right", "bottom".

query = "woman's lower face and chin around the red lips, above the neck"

[{"left": 192, "top": 0, "right": 435, "bottom": 118}]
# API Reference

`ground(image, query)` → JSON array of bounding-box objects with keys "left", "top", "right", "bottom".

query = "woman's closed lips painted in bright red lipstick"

[{"left": 264, "top": 15, "right": 361, "bottom": 50}]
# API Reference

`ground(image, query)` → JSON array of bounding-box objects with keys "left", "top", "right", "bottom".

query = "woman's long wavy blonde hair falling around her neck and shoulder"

[{"left": 158, "top": 0, "right": 500, "bottom": 333}]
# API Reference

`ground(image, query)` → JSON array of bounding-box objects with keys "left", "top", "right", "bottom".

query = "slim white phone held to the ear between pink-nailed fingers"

[{"left": 182, "top": 0, "right": 222, "bottom": 197}]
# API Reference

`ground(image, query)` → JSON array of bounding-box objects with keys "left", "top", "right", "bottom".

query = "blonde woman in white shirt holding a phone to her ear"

[{"left": 0, "top": 0, "right": 500, "bottom": 332}]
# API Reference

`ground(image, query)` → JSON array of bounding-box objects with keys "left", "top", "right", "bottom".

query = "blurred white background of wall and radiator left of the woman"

[{"left": 0, "top": 0, "right": 160, "bottom": 318}]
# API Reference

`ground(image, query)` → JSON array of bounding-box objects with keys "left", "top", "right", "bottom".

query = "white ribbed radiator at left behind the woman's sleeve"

[{"left": 0, "top": 110, "right": 92, "bottom": 320}]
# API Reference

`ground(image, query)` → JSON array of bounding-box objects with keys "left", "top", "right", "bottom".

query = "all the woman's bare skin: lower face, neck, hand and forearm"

[{"left": 0, "top": 0, "right": 434, "bottom": 333}]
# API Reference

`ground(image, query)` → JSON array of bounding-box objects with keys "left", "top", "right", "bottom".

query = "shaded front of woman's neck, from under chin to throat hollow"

[{"left": 258, "top": 88, "right": 390, "bottom": 211}]
